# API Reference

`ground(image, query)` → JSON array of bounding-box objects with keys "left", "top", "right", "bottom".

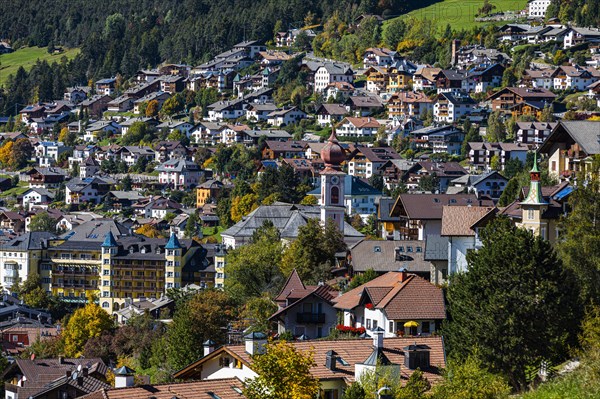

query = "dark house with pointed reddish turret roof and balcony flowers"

[{"left": 269, "top": 269, "right": 338, "bottom": 338}]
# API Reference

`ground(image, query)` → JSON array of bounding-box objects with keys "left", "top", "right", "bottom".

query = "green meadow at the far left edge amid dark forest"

[{"left": 0, "top": 47, "right": 79, "bottom": 86}]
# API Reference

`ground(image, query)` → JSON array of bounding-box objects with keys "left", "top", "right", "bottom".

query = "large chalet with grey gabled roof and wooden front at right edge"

[{"left": 539, "top": 121, "right": 600, "bottom": 178}]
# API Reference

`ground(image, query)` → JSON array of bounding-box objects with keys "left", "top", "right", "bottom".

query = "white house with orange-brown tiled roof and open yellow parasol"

[{"left": 334, "top": 271, "right": 446, "bottom": 337}]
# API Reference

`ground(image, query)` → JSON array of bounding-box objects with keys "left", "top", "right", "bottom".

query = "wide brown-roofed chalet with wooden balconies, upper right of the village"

[{"left": 487, "top": 87, "right": 556, "bottom": 117}]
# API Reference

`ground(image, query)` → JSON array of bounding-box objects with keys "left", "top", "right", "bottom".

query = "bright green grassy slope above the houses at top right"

[{"left": 386, "top": 0, "right": 527, "bottom": 30}]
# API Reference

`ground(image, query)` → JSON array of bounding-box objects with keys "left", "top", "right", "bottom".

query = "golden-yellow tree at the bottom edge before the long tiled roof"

[{"left": 244, "top": 341, "right": 320, "bottom": 399}]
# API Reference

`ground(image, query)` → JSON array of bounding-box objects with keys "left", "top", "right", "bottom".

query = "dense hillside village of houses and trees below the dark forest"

[{"left": 0, "top": 0, "right": 600, "bottom": 399}]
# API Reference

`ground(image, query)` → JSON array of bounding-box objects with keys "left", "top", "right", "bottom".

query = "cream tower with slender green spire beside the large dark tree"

[{"left": 520, "top": 153, "right": 549, "bottom": 239}]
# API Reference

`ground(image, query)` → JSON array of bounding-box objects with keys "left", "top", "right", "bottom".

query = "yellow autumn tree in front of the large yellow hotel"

[{"left": 63, "top": 301, "right": 114, "bottom": 357}]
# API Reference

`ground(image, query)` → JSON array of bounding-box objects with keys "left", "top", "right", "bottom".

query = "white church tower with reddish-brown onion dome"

[{"left": 320, "top": 126, "right": 346, "bottom": 233}]
